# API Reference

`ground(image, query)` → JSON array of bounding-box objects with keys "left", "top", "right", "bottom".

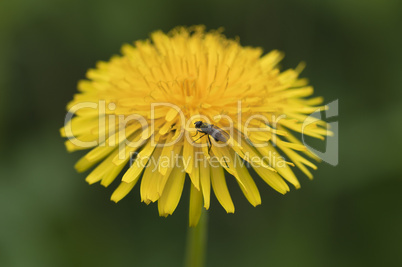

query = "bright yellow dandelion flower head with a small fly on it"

[{"left": 61, "top": 26, "right": 327, "bottom": 225}]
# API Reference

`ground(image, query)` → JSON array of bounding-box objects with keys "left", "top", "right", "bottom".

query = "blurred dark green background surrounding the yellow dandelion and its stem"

[{"left": 0, "top": 0, "right": 402, "bottom": 266}]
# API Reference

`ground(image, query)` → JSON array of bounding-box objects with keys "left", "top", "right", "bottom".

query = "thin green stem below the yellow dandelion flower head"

[{"left": 185, "top": 209, "right": 208, "bottom": 267}]
